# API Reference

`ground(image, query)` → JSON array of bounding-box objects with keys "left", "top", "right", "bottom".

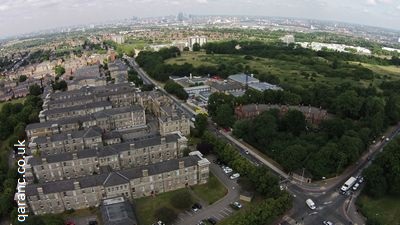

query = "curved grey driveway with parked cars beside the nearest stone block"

[{"left": 175, "top": 159, "right": 239, "bottom": 225}]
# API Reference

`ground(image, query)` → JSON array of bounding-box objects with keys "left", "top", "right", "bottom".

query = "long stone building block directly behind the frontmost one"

[{"left": 28, "top": 134, "right": 187, "bottom": 182}]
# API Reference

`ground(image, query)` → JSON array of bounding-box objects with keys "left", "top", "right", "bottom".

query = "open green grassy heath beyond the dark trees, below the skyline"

[{"left": 166, "top": 52, "right": 400, "bottom": 88}]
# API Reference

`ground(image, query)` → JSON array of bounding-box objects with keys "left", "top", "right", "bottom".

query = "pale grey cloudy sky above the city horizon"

[{"left": 0, "top": 0, "right": 400, "bottom": 38}]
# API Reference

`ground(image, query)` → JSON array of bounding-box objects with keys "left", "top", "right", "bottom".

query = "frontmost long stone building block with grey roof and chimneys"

[{"left": 26, "top": 152, "right": 210, "bottom": 215}]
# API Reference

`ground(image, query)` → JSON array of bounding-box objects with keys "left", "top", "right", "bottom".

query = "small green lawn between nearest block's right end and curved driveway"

[{"left": 193, "top": 173, "right": 228, "bottom": 204}]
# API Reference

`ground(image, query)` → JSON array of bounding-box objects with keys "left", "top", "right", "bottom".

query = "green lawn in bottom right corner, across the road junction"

[{"left": 358, "top": 195, "right": 400, "bottom": 225}]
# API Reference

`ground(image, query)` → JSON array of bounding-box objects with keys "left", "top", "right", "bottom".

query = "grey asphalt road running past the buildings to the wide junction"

[{"left": 128, "top": 58, "right": 400, "bottom": 225}]
